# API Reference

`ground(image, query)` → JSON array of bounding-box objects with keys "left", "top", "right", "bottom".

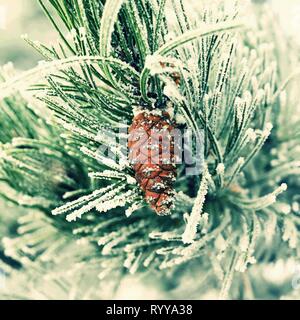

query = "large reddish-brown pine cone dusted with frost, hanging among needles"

[{"left": 128, "top": 111, "right": 176, "bottom": 215}]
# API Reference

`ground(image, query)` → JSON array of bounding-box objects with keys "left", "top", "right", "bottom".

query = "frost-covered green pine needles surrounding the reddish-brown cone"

[{"left": 0, "top": 0, "right": 300, "bottom": 298}]
